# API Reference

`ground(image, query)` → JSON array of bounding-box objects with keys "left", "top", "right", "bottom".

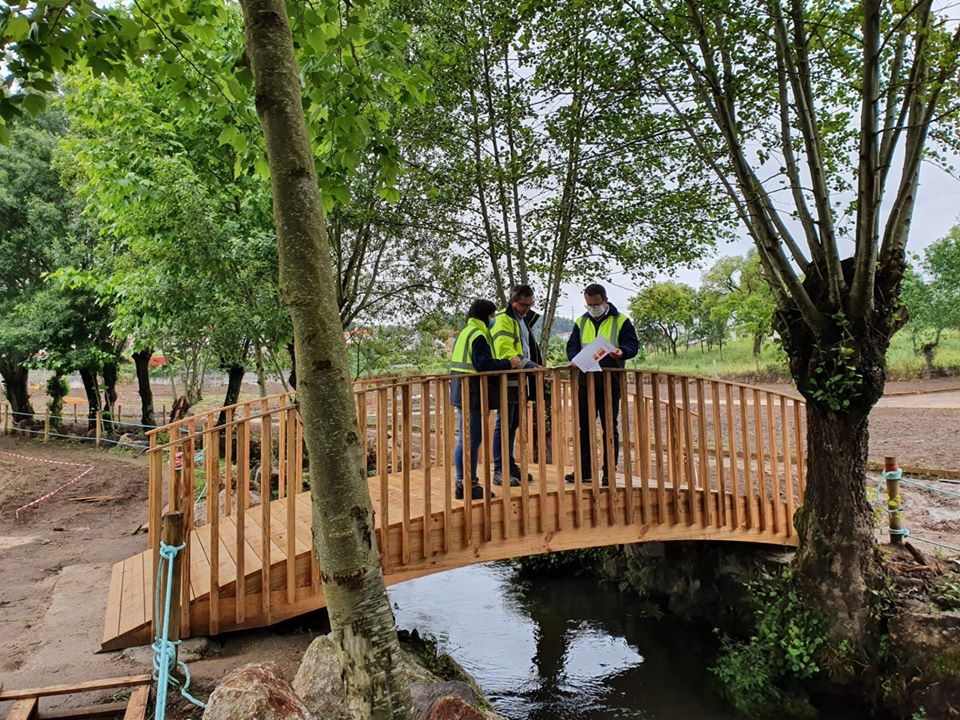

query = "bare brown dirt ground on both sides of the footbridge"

[{"left": 0, "top": 378, "right": 960, "bottom": 718}]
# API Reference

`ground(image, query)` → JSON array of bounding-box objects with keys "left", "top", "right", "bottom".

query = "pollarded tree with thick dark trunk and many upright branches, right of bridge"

[{"left": 605, "top": 0, "right": 960, "bottom": 647}]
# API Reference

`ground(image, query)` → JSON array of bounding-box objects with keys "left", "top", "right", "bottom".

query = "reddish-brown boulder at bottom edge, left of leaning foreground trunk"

[{"left": 203, "top": 663, "right": 316, "bottom": 720}]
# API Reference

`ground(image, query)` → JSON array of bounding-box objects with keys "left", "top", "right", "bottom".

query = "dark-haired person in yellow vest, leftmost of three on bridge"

[{"left": 450, "top": 300, "right": 522, "bottom": 500}]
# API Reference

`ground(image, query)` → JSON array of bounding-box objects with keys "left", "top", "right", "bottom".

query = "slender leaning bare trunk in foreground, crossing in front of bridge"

[{"left": 241, "top": 0, "right": 410, "bottom": 720}]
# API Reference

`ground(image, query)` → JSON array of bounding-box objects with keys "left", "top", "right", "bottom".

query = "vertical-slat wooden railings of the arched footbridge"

[{"left": 148, "top": 368, "right": 805, "bottom": 636}]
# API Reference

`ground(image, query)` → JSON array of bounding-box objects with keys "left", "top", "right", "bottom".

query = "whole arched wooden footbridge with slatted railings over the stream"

[{"left": 103, "top": 369, "right": 805, "bottom": 649}]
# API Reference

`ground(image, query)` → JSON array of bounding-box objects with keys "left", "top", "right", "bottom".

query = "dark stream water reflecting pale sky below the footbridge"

[{"left": 390, "top": 565, "right": 736, "bottom": 720}]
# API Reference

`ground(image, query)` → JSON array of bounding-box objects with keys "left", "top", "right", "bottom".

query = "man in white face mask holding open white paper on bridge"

[{"left": 566, "top": 283, "right": 640, "bottom": 485}]
